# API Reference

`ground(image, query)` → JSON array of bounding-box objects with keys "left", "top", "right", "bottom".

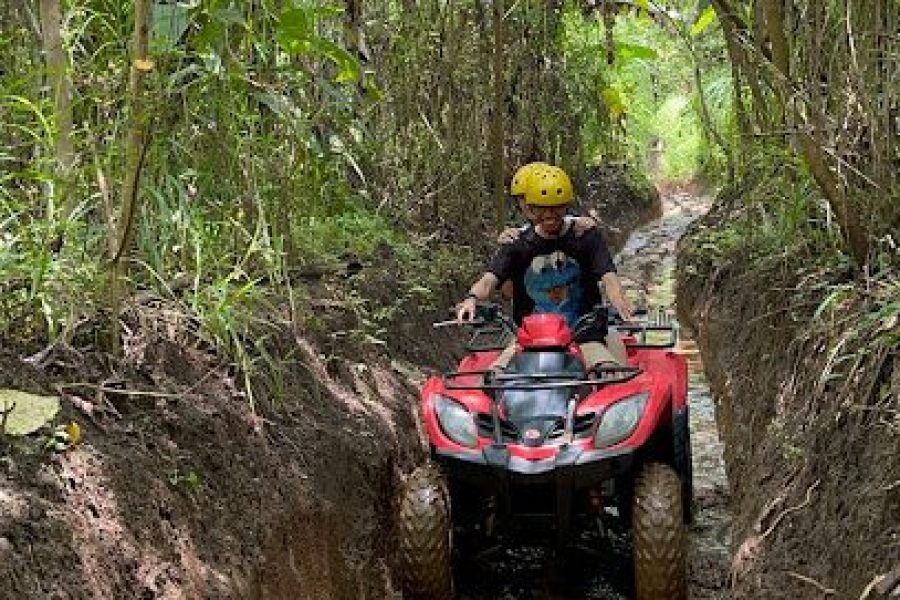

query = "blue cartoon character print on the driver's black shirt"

[{"left": 525, "top": 251, "right": 582, "bottom": 326}]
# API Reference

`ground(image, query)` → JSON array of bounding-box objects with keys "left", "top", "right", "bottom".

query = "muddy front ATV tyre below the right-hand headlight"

[{"left": 631, "top": 463, "right": 687, "bottom": 600}]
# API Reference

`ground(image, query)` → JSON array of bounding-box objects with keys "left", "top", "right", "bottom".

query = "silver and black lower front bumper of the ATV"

[{"left": 432, "top": 445, "right": 634, "bottom": 490}]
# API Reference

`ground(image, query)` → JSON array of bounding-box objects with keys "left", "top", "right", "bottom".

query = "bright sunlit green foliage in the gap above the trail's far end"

[{"left": 566, "top": 6, "right": 732, "bottom": 180}]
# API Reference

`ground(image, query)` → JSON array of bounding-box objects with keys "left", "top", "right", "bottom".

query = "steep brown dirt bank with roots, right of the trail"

[{"left": 677, "top": 185, "right": 900, "bottom": 599}]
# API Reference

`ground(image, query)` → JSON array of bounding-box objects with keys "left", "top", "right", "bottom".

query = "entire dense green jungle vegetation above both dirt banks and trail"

[{"left": 0, "top": 0, "right": 900, "bottom": 367}]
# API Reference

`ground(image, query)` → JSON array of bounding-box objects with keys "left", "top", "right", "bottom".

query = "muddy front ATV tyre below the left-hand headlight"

[{"left": 399, "top": 464, "right": 453, "bottom": 600}]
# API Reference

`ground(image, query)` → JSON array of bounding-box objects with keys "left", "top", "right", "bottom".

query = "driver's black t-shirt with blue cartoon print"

[{"left": 488, "top": 227, "right": 616, "bottom": 326}]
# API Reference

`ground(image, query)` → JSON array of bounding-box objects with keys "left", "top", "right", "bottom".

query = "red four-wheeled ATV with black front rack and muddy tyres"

[{"left": 399, "top": 303, "right": 692, "bottom": 600}]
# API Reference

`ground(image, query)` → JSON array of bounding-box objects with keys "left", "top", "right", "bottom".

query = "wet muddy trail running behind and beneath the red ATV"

[{"left": 456, "top": 191, "right": 731, "bottom": 600}]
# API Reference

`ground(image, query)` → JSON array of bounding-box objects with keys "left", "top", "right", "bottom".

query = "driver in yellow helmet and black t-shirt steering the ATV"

[{"left": 457, "top": 166, "right": 631, "bottom": 368}]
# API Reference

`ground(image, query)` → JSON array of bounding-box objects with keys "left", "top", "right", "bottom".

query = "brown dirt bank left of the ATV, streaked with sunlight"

[{"left": 0, "top": 307, "right": 421, "bottom": 600}]
